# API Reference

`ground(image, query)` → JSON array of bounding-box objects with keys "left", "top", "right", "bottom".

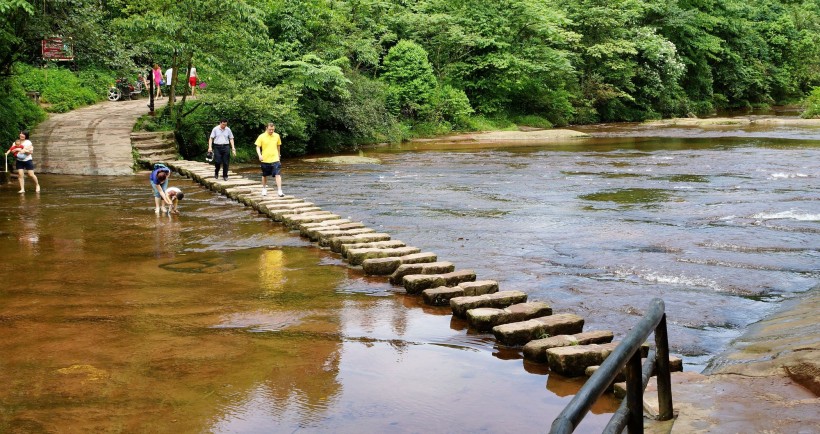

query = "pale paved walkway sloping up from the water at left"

[{"left": 31, "top": 98, "right": 167, "bottom": 175}]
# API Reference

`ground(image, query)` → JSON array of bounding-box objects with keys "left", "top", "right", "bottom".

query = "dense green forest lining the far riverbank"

[{"left": 0, "top": 0, "right": 820, "bottom": 158}]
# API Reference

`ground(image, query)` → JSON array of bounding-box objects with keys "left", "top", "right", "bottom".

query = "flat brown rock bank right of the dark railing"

[{"left": 650, "top": 287, "right": 820, "bottom": 433}]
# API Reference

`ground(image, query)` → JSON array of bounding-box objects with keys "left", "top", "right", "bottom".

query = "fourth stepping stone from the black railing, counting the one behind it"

[{"left": 493, "top": 313, "right": 584, "bottom": 348}]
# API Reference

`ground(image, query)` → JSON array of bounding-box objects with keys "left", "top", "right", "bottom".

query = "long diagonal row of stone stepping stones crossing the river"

[{"left": 166, "top": 160, "right": 682, "bottom": 377}]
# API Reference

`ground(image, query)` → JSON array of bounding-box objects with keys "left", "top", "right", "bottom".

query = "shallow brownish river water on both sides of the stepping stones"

[{"left": 0, "top": 120, "right": 820, "bottom": 433}]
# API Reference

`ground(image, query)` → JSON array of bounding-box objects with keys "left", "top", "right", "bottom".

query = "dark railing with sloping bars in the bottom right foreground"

[{"left": 550, "top": 298, "right": 672, "bottom": 434}]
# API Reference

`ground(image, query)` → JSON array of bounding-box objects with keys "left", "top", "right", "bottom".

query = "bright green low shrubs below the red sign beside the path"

[{"left": 15, "top": 63, "right": 102, "bottom": 113}]
